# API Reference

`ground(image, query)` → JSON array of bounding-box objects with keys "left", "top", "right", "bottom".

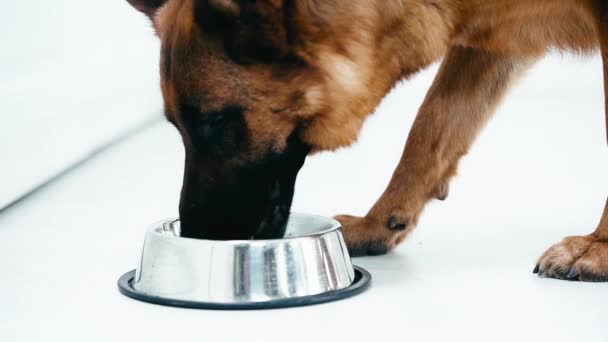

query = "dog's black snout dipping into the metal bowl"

[{"left": 180, "top": 130, "right": 310, "bottom": 240}]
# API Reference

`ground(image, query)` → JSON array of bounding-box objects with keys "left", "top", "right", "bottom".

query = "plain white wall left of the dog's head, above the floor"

[{"left": 0, "top": 0, "right": 161, "bottom": 209}]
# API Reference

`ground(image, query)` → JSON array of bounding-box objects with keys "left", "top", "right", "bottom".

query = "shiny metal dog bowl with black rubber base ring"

[{"left": 119, "top": 213, "right": 371, "bottom": 309}]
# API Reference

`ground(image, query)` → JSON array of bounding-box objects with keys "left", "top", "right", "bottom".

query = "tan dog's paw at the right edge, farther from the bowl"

[{"left": 534, "top": 236, "right": 608, "bottom": 281}]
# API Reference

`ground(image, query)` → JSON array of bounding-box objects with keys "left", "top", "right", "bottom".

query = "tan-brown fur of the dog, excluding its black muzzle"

[{"left": 130, "top": 0, "right": 608, "bottom": 280}]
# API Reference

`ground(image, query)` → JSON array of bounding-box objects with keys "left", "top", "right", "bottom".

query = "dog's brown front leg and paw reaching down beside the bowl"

[{"left": 336, "top": 47, "right": 531, "bottom": 256}]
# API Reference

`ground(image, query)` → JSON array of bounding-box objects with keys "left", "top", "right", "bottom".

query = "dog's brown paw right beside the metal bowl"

[{"left": 334, "top": 215, "right": 406, "bottom": 257}]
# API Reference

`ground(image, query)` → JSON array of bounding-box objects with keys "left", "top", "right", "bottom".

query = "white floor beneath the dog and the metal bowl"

[{"left": 0, "top": 57, "right": 608, "bottom": 342}]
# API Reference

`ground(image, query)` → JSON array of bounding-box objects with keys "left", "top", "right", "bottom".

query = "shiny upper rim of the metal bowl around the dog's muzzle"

[{"left": 148, "top": 212, "right": 342, "bottom": 245}]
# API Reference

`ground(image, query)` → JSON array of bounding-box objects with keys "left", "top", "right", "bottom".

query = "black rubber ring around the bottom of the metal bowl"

[{"left": 118, "top": 266, "right": 372, "bottom": 310}]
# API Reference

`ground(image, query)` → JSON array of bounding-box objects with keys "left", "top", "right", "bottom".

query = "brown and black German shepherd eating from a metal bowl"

[{"left": 129, "top": 0, "right": 608, "bottom": 281}]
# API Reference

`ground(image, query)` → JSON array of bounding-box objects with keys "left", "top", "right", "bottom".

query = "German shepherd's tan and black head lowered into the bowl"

[{"left": 128, "top": 0, "right": 384, "bottom": 239}]
